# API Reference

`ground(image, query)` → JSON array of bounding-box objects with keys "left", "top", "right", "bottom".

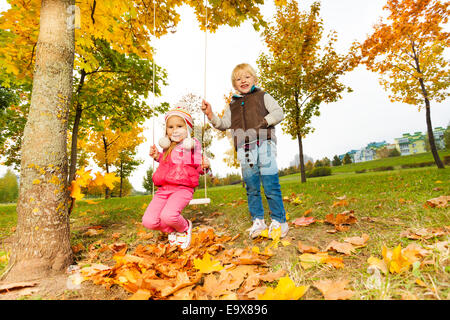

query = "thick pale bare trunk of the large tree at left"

[{"left": 6, "top": 0, "right": 74, "bottom": 281}]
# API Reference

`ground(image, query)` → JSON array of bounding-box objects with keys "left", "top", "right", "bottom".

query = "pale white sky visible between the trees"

[{"left": 0, "top": 0, "right": 450, "bottom": 191}]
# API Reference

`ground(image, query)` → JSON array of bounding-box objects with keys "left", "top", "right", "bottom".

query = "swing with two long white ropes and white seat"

[{"left": 152, "top": 0, "right": 211, "bottom": 204}]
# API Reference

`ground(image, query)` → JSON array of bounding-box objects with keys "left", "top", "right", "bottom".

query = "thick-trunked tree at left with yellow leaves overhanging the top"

[{"left": 0, "top": 0, "right": 263, "bottom": 281}]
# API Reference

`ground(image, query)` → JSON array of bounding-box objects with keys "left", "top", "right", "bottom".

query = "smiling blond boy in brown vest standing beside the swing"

[{"left": 202, "top": 63, "right": 289, "bottom": 238}]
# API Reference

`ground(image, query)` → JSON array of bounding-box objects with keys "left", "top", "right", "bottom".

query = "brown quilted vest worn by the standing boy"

[{"left": 230, "top": 88, "right": 276, "bottom": 150}]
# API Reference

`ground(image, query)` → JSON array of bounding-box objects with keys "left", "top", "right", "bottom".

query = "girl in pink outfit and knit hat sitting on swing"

[{"left": 142, "top": 108, "right": 209, "bottom": 249}]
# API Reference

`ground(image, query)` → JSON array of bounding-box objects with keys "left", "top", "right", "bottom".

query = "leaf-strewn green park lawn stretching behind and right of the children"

[{"left": 0, "top": 167, "right": 450, "bottom": 299}]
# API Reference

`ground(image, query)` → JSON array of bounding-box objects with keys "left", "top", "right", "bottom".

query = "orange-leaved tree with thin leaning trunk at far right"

[{"left": 361, "top": 0, "right": 450, "bottom": 168}]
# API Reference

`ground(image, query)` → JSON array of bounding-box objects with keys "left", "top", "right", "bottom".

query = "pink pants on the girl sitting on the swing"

[{"left": 142, "top": 185, "right": 194, "bottom": 233}]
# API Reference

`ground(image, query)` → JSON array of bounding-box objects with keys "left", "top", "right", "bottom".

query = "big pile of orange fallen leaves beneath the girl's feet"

[{"left": 81, "top": 229, "right": 299, "bottom": 300}]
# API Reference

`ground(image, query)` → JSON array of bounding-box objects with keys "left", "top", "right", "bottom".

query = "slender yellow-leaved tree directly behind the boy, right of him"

[{"left": 258, "top": 1, "right": 358, "bottom": 182}]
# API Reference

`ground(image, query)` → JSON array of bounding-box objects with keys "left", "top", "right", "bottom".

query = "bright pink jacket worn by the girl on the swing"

[{"left": 153, "top": 138, "right": 207, "bottom": 188}]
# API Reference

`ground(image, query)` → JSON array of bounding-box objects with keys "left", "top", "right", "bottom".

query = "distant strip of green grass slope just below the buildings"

[{"left": 332, "top": 150, "right": 450, "bottom": 174}]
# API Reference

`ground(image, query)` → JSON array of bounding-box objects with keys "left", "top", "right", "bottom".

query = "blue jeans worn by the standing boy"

[{"left": 237, "top": 140, "right": 286, "bottom": 223}]
